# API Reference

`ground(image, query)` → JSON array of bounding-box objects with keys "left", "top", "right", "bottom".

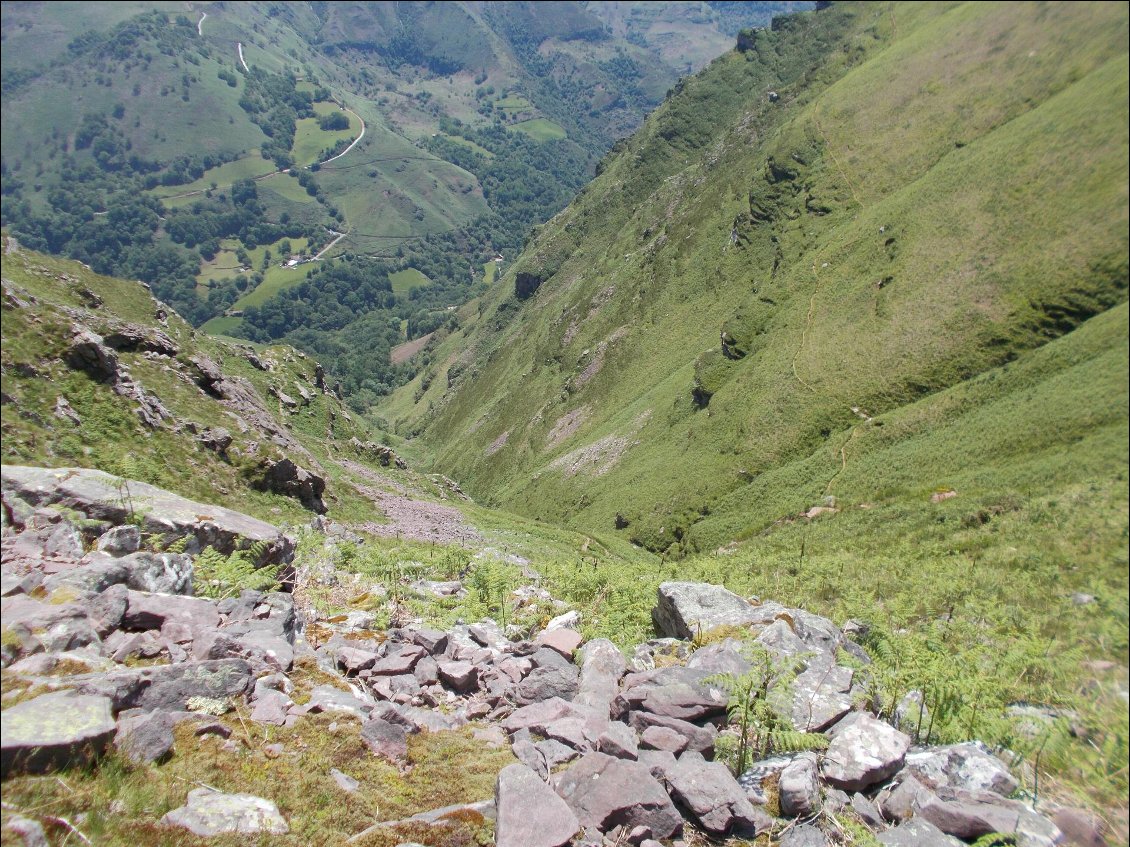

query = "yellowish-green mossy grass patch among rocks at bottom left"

[{"left": 5, "top": 714, "right": 513, "bottom": 847}]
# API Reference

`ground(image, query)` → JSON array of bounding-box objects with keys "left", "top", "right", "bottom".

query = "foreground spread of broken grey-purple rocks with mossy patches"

[{"left": 0, "top": 469, "right": 1080, "bottom": 847}]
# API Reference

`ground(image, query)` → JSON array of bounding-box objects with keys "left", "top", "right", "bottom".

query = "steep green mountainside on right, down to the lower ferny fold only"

[{"left": 386, "top": 3, "right": 1127, "bottom": 553}]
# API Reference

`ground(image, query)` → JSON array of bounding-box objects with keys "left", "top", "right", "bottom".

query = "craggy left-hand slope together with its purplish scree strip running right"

[{"left": 0, "top": 233, "right": 651, "bottom": 578}]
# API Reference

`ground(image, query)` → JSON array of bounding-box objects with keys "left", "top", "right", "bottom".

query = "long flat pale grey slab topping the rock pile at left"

[{"left": 0, "top": 465, "right": 294, "bottom": 565}]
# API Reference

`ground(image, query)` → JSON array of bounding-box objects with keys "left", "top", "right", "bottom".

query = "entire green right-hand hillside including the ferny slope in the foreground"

[{"left": 372, "top": 3, "right": 1130, "bottom": 817}]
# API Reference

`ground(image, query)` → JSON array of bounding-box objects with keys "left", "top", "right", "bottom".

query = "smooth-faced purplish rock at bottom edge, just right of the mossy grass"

[{"left": 495, "top": 765, "right": 581, "bottom": 847}]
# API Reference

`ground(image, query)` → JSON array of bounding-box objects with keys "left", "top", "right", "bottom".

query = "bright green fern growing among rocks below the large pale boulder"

[{"left": 705, "top": 644, "right": 828, "bottom": 774}]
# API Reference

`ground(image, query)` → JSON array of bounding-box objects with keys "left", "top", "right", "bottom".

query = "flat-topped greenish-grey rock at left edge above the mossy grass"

[{"left": 0, "top": 691, "right": 118, "bottom": 777}]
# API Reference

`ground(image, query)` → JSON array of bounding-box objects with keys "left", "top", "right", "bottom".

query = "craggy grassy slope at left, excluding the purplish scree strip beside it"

[{"left": 0, "top": 235, "right": 400, "bottom": 522}]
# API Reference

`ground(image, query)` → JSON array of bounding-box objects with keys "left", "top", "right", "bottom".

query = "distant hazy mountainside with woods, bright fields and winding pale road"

[{"left": 0, "top": 2, "right": 810, "bottom": 411}]
